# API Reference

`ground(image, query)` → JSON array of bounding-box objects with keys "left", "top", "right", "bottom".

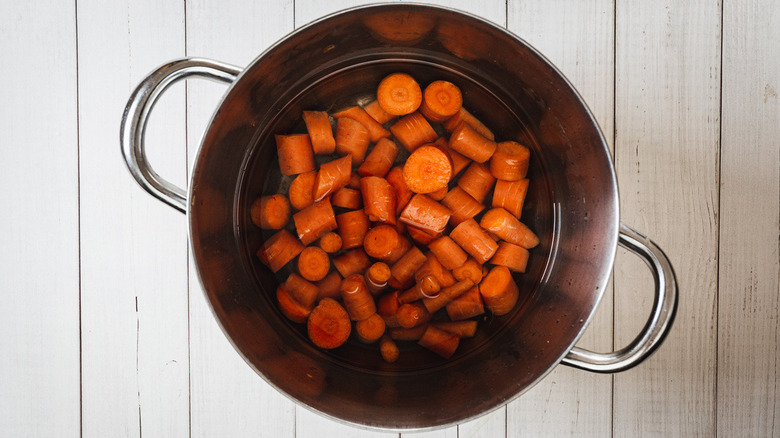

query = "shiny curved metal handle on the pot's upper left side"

[{"left": 119, "top": 58, "right": 242, "bottom": 213}]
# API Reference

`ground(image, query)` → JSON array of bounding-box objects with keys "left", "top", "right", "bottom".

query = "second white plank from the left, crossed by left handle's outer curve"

[{"left": 78, "top": 0, "right": 189, "bottom": 437}]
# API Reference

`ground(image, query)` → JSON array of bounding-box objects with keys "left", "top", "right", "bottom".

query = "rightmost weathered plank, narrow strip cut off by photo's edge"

[{"left": 717, "top": 0, "right": 780, "bottom": 436}]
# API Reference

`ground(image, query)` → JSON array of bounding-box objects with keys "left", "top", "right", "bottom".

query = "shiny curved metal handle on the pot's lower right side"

[{"left": 561, "top": 223, "right": 677, "bottom": 373}]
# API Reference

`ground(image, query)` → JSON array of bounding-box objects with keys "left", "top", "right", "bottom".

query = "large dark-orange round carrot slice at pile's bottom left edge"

[{"left": 306, "top": 298, "right": 352, "bottom": 349}]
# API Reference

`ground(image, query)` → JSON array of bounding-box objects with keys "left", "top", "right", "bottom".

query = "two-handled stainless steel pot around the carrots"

[{"left": 121, "top": 3, "right": 677, "bottom": 430}]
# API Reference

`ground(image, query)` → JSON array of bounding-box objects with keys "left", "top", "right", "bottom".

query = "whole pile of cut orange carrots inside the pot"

[{"left": 251, "top": 73, "right": 539, "bottom": 362}]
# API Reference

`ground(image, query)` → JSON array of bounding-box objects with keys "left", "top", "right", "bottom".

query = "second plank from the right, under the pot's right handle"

[{"left": 613, "top": 0, "right": 721, "bottom": 436}]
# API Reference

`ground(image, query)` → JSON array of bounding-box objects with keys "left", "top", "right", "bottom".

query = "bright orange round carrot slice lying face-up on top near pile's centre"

[{"left": 403, "top": 145, "right": 452, "bottom": 193}]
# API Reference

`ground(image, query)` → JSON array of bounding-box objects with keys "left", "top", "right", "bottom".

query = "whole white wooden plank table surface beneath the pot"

[{"left": 0, "top": 0, "right": 780, "bottom": 438}]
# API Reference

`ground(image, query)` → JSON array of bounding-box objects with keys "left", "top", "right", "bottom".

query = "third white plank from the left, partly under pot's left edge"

[{"left": 186, "top": 0, "right": 295, "bottom": 438}]
